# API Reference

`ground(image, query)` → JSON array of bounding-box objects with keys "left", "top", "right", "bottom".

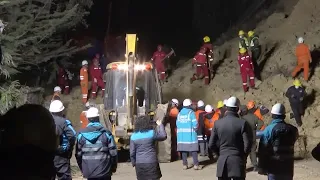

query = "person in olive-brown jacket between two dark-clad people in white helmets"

[{"left": 240, "top": 105, "right": 263, "bottom": 171}]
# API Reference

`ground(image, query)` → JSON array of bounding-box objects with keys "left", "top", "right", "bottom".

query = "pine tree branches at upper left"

[{"left": 0, "top": 0, "right": 92, "bottom": 113}]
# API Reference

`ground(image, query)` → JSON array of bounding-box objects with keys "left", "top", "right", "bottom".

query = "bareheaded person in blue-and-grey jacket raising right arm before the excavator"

[{"left": 130, "top": 116, "right": 167, "bottom": 180}]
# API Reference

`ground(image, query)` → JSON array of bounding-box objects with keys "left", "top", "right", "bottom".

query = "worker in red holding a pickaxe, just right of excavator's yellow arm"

[{"left": 151, "top": 45, "right": 167, "bottom": 81}]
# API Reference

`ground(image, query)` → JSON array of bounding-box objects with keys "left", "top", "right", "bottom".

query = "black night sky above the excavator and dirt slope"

[{"left": 88, "top": 0, "right": 277, "bottom": 56}]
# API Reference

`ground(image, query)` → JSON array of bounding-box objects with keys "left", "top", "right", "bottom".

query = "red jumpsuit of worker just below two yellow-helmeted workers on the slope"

[{"left": 238, "top": 53, "right": 255, "bottom": 92}]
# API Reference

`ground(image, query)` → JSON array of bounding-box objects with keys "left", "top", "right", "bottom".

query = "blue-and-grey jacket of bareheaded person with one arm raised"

[{"left": 130, "top": 124, "right": 167, "bottom": 166}]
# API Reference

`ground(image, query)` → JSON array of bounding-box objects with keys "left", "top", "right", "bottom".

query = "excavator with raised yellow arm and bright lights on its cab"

[{"left": 100, "top": 34, "right": 171, "bottom": 162}]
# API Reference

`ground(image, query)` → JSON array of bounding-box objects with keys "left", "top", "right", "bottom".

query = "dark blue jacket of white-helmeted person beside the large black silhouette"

[{"left": 53, "top": 115, "right": 76, "bottom": 158}]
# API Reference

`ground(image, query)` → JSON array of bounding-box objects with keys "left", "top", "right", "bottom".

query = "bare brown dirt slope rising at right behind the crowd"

[{"left": 163, "top": 0, "right": 320, "bottom": 153}]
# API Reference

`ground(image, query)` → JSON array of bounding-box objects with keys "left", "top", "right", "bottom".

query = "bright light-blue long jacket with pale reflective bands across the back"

[{"left": 176, "top": 107, "right": 199, "bottom": 152}]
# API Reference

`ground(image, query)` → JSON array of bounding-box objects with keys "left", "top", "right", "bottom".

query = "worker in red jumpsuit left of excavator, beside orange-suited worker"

[{"left": 89, "top": 56, "right": 105, "bottom": 98}]
